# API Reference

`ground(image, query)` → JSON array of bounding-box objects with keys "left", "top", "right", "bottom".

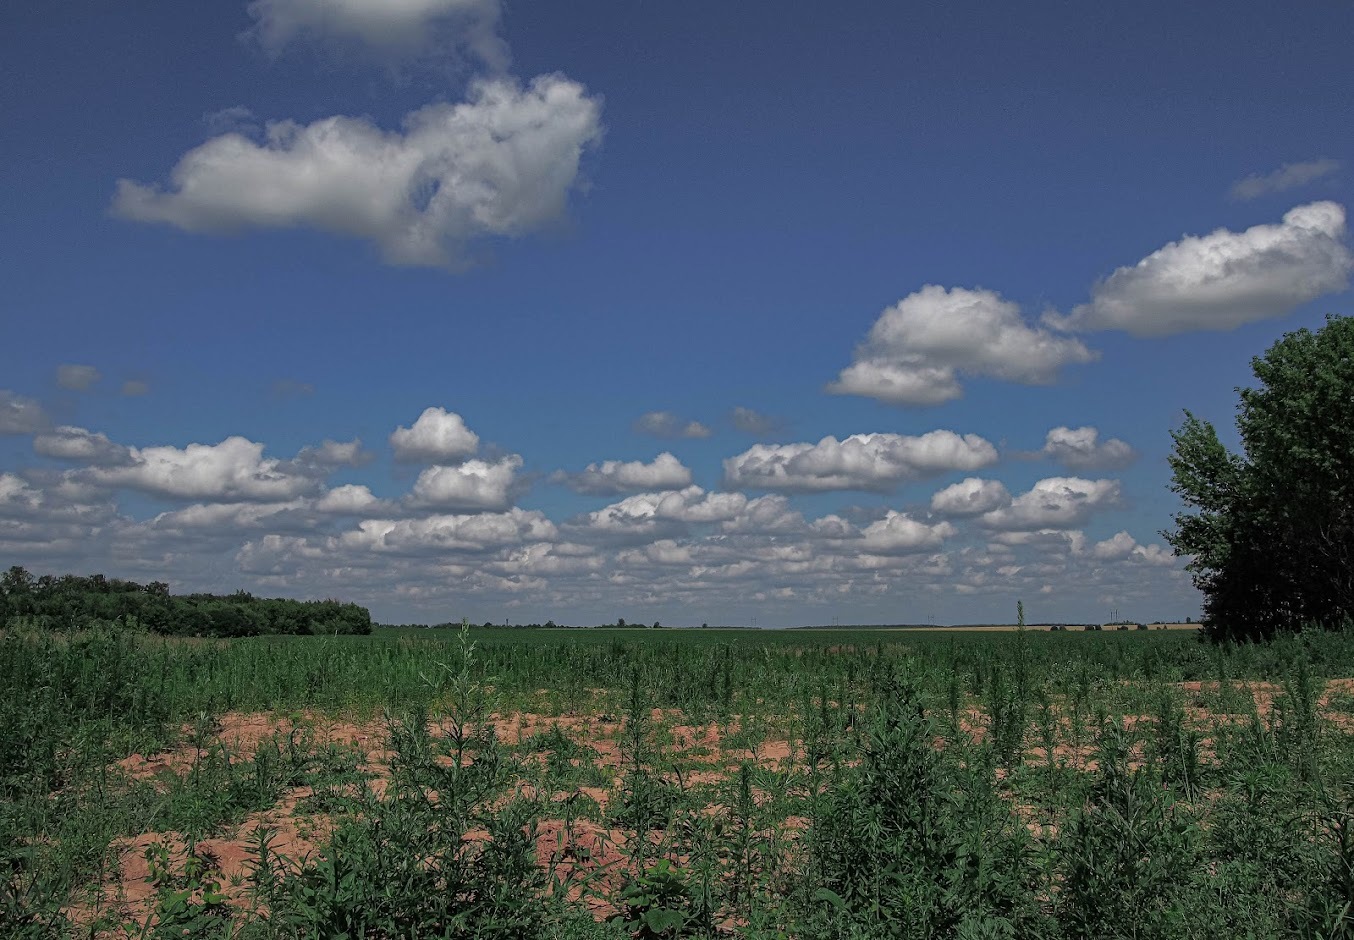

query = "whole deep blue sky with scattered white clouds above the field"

[{"left": 0, "top": 0, "right": 1354, "bottom": 627}]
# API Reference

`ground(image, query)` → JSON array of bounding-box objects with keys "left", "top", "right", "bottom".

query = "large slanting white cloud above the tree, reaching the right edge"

[{"left": 1044, "top": 202, "right": 1354, "bottom": 336}]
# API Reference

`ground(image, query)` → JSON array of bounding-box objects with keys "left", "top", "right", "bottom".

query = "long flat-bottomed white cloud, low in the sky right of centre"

[{"left": 724, "top": 431, "right": 997, "bottom": 492}]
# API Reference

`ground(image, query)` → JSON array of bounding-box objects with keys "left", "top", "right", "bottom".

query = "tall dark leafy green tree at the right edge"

[{"left": 1162, "top": 317, "right": 1354, "bottom": 638}]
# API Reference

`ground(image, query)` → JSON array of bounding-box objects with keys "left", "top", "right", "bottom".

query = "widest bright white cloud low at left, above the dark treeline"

[{"left": 80, "top": 436, "right": 317, "bottom": 501}]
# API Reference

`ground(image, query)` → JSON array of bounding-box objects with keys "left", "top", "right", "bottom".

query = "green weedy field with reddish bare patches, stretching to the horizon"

[{"left": 0, "top": 623, "right": 1354, "bottom": 940}]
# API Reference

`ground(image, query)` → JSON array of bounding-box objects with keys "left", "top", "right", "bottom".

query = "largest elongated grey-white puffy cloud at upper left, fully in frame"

[{"left": 112, "top": 75, "right": 601, "bottom": 267}]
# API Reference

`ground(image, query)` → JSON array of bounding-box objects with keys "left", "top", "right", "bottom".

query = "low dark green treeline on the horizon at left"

[{"left": 0, "top": 565, "right": 371, "bottom": 637}]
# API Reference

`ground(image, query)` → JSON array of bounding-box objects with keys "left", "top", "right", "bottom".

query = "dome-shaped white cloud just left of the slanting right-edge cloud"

[{"left": 827, "top": 284, "right": 1095, "bottom": 405}]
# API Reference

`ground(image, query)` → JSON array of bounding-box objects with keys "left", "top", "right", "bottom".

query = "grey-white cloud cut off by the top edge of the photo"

[{"left": 246, "top": 0, "right": 508, "bottom": 69}]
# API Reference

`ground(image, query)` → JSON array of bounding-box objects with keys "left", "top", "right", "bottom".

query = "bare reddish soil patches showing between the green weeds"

[{"left": 69, "top": 680, "right": 1354, "bottom": 936}]
